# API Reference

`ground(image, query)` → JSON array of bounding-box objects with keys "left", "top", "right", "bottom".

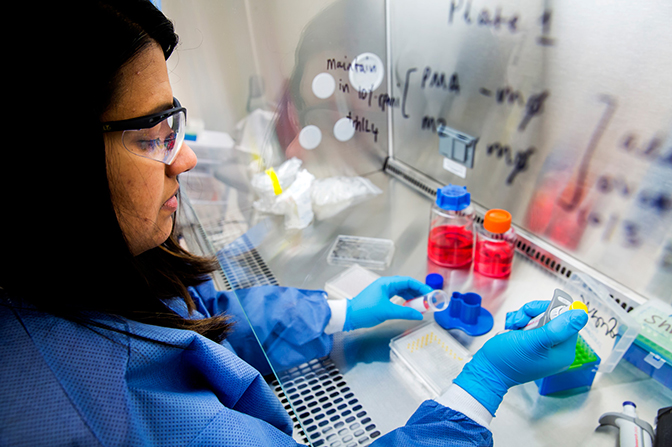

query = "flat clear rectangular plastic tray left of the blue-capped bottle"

[{"left": 327, "top": 234, "right": 394, "bottom": 270}]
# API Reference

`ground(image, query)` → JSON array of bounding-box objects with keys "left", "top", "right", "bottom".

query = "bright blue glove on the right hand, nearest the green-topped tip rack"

[{"left": 454, "top": 302, "right": 588, "bottom": 416}]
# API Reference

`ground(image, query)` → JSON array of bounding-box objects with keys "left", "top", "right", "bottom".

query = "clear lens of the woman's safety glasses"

[{"left": 122, "top": 111, "right": 186, "bottom": 165}]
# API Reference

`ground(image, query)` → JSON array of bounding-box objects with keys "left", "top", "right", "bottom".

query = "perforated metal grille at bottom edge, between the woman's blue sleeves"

[{"left": 271, "top": 357, "right": 381, "bottom": 447}]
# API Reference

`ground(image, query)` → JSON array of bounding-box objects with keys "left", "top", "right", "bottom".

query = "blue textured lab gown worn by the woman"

[{"left": 0, "top": 282, "right": 492, "bottom": 446}]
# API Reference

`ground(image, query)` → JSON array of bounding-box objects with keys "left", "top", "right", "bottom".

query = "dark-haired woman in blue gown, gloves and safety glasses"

[{"left": 0, "top": 0, "right": 587, "bottom": 446}]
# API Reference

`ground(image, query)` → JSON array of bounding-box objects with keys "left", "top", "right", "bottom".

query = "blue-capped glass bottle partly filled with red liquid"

[{"left": 427, "top": 185, "right": 474, "bottom": 268}]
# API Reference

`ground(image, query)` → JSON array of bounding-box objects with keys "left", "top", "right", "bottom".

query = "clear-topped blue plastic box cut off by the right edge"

[{"left": 624, "top": 300, "right": 672, "bottom": 389}]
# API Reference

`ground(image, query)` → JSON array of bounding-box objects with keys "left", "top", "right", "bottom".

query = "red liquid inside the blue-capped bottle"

[{"left": 427, "top": 225, "right": 474, "bottom": 267}]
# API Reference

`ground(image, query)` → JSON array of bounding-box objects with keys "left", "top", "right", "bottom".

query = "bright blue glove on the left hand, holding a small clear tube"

[{"left": 343, "top": 276, "right": 434, "bottom": 331}]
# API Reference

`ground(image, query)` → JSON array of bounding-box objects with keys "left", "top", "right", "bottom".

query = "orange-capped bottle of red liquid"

[{"left": 474, "top": 209, "right": 516, "bottom": 278}]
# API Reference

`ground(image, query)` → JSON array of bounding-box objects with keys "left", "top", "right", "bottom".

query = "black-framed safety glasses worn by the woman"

[{"left": 102, "top": 98, "right": 187, "bottom": 165}]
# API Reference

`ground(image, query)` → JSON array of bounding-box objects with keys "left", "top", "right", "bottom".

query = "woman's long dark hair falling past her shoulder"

[{"left": 0, "top": 0, "right": 230, "bottom": 341}]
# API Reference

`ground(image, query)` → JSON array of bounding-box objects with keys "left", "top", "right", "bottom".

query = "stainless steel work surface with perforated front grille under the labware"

[{"left": 176, "top": 166, "right": 672, "bottom": 447}]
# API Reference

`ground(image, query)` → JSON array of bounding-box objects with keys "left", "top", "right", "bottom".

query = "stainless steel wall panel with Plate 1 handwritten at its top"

[{"left": 387, "top": 0, "right": 672, "bottom": 301}]
